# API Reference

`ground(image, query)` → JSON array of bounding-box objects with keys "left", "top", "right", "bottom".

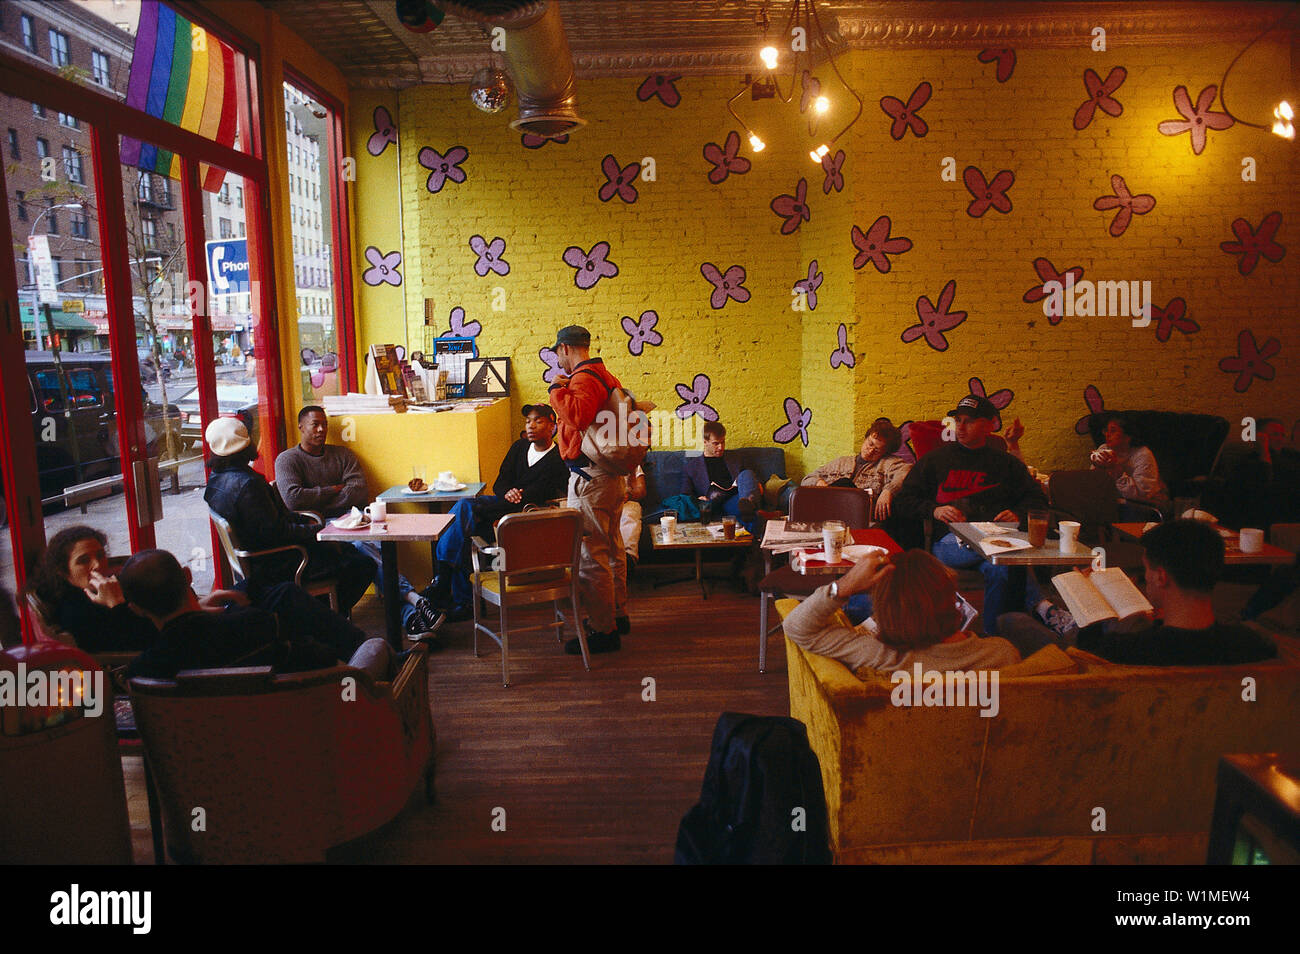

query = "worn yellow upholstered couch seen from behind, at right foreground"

[{"left": 779, "top": 600, "right": 1300, "bottom": 864}]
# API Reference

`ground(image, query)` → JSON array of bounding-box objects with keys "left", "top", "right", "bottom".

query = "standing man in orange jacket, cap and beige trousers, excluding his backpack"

[{"left": 550, "top": 325, "right": 629, "bottom": 655}]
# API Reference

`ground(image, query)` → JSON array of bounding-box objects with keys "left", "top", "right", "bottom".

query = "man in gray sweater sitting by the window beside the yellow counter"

[{"left": 276, "top": 404, "right": 447, "bottom": 639}]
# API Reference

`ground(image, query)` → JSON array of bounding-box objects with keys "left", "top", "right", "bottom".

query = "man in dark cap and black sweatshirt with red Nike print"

[{"left": 894, "top": 394, "right": 1048, "bottom": 636}]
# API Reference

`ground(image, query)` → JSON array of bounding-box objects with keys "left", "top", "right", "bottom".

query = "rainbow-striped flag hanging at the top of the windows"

[{"left": 122, "top": 0, "right": 244, "bottom": 192}]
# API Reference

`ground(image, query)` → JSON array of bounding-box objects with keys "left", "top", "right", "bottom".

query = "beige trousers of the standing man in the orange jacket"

[{"left": 568, "top": 469, "right": 628, "bottom": 633}]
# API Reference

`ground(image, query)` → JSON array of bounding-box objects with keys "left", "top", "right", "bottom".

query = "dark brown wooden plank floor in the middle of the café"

[{"left": 125, "top": 564, "right": 789, "bottom": 864}]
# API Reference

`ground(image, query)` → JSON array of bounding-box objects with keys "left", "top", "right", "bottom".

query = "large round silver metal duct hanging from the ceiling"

[{"left": 438, "top": 0, "right": 586, "bottom": 136}]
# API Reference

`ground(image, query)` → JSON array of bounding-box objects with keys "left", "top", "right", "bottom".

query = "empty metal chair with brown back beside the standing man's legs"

[{"left": 469, "top": 507, "right": 592, "bottom": 686}]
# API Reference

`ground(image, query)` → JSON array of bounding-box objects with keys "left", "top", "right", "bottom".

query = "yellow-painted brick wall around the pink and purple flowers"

[{"left": 352, "top": 36, "right": 1300, "bottom": 474}]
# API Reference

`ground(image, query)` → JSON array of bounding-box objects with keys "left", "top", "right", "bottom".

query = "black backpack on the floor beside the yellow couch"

[{"left": 673, "top": 712, "right": 831, "bottom": 864}]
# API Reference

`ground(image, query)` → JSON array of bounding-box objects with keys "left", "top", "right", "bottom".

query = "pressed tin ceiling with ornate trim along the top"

[{"left": 263, "top": 0, "right": 1290, "bottom": 88}]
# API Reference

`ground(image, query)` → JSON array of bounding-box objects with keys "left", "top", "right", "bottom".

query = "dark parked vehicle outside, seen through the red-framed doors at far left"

[{"left": 26, "top": 351, "right": 181, "bottom": 498}]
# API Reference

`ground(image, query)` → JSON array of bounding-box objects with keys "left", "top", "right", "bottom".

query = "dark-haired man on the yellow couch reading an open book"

[{"left": 998, "top": 520, "right": 1277, "bottom": 665}]
